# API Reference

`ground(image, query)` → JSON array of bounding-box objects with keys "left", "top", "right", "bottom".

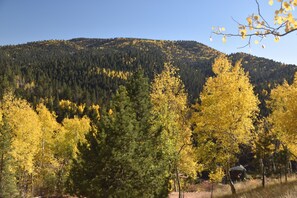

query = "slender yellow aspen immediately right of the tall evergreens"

[{"left": 151, "top": 64, "right": 196, "bottom": 195}]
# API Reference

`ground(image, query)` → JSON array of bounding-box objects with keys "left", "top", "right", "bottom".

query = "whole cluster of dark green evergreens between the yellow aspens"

[{"left": 69, "top": 72, "right": 168, "bottom": 197}]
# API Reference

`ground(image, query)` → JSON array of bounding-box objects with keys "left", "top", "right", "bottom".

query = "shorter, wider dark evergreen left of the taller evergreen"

[{"left": 71, "top": 86, "right": 140, "bottom": 197}]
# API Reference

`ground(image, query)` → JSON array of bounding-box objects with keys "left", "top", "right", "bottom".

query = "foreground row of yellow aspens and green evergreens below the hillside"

[{"left": 0, "top": 56, "right": 297, "bottom": 197}]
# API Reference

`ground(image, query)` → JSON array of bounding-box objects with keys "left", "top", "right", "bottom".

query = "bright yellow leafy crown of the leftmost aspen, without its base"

[{"left": 1, "top": 93, "right": 41, "bottom": 173}]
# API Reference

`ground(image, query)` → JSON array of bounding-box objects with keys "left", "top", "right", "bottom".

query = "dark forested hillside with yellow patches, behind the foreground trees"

[{"left": 0, "top": 38, "right": 296, "bottom": 114}]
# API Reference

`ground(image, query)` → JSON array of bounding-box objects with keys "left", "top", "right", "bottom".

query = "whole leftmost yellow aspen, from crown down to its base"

[{"left": 1, "top": 93, "right": 41, "bottom": 196}]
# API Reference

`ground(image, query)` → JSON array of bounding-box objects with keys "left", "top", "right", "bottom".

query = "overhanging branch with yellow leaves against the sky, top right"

[{"left": 212, "top": 0, "right": 297, "bottom": 44}]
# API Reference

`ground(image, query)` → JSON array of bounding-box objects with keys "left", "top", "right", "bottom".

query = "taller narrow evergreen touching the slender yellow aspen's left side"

[{"left": 127, "top": 68, "right": 168, "bottom": 197}]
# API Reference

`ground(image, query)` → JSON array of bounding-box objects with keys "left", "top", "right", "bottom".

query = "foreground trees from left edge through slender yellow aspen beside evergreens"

[{"left": 0, "top": 64, "right": 197, "bottom": 197}]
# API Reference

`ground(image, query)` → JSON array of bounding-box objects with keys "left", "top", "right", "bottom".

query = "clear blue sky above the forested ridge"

[{"left": 0, "top": 0, "right": 297, "bottom": 64}]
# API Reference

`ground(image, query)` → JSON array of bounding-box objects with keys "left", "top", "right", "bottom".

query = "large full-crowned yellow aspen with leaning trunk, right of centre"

[{"left": 192, "top": 56, "right": 259, "bottom": 193}]
